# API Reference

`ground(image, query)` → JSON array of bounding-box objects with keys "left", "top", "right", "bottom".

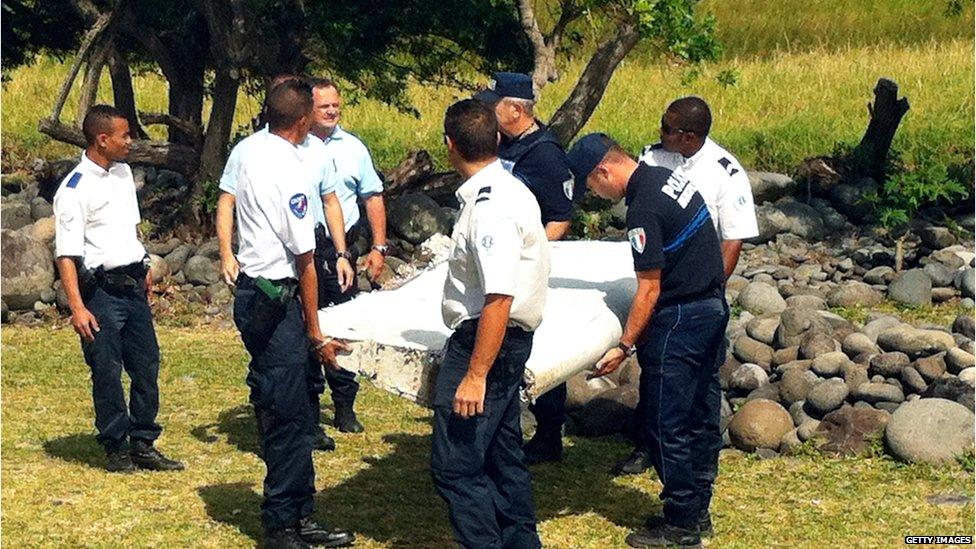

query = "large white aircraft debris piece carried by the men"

[{"left": 319, "top": 242, "right": 637, "bottom": 405}]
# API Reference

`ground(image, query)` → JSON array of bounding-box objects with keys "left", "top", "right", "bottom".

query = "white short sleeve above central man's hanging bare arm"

[{"left": 468, "top": 208, "right": 522, "bottom": 296}]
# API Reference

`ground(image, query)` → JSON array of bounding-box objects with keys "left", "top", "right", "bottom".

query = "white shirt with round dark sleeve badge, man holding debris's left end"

[{"left": 234, "top": 132, "right": 315, "bottom": 280}]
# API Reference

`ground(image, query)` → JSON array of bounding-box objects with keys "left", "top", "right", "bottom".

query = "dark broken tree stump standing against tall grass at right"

[{"left": 853, "top": 78, "right": 909, "bottom": 183}]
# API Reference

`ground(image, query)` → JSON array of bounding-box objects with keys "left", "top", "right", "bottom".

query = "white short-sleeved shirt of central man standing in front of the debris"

[{"left": 441, "top": 160, "right": 549, "bottom": 331}]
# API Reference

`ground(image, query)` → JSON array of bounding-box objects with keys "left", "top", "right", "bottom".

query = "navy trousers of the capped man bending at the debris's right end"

[{"left": 637, "top": 297, "right": 729, "bottom": 526}]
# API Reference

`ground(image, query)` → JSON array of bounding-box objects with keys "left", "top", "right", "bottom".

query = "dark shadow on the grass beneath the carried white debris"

[{"left": 316, "top": 433, "right": 660, "bottom": 547}]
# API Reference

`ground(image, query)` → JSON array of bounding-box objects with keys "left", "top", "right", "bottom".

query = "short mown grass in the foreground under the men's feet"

[{"left": 0, "top": 327, "right": 974, "bottom": 548}]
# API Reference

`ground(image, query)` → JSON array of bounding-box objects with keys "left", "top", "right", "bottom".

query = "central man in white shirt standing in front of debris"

[{"left": 431, "top": 99, "right": 549, "bottom": 549}]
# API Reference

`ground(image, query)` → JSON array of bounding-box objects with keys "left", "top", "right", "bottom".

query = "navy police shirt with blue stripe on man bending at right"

[{"left": 626, "top": 164, "right": 725, "bottom": 307}]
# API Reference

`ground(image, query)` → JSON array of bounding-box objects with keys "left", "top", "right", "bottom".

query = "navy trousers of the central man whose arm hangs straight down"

[{"left": 431, "top": 320, "right": 541, "bottom": 549}]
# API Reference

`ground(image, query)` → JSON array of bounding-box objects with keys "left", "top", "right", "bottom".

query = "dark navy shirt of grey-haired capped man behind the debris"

[{"left": 498, "top": 125, "right": 576, "bottom": 225}]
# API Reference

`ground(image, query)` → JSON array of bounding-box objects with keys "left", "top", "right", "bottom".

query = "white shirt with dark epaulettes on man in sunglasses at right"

[{"left": 640, "top": 137, "right": 759, "bottom": 240}]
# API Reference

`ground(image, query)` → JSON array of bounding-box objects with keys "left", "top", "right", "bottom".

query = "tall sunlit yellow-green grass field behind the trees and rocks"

[{"left": 2, "top": 0, "right": 974, "bottom": 172}]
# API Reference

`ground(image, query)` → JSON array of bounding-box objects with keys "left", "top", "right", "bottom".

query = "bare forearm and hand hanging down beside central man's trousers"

[{"left": 454, "top": 294, "right": 514, "bottom": 419}]
